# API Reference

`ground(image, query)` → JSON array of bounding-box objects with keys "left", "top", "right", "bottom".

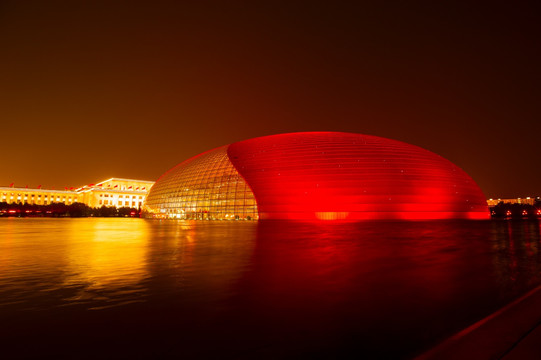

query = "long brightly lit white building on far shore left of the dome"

[{"left": 0, "top": 178, "right": 154, "bottom": 208}]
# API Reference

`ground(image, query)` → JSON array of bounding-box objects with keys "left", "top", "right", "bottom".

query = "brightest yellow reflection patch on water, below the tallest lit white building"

[{"left": 64, "top": 219, "right": 150, "bottom": 306}]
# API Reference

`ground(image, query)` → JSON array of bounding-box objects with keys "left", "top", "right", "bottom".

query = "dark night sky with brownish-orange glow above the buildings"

[{"left": 0, "top": 0, "right": 541, "bottom": 197}]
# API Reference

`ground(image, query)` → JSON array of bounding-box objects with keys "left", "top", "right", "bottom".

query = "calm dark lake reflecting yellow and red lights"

[{"left": 0, "top": 218, "right": 541, "bottom": 359}]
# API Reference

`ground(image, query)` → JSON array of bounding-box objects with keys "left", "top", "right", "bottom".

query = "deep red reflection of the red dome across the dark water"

[{"left": 232, "top": 221, "right": 541, "bottom": 358}]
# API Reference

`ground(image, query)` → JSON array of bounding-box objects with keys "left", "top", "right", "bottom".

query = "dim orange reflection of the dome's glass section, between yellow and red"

[{"left": 141, "top": 220, "right": 257, "bottom": 305}]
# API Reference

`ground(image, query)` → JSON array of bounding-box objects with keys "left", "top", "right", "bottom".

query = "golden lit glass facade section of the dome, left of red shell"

[{"left": 143, "top": 146, "right": 258, "bottom": 220}]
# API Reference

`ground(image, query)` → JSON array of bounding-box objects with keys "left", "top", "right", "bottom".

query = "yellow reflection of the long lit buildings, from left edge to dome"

[{"left": 0, "top": 218, "right": 150, "bottom": 309}]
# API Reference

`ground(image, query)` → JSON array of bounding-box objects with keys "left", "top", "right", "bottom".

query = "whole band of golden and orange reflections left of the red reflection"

[{"left": 0, "top": 218, "right": 255, "bottom": 310}]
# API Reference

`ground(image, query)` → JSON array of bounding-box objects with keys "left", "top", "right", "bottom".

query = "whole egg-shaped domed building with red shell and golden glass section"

[{"left": 143, "top": 132, "right": 489, "bottom": 220}]
